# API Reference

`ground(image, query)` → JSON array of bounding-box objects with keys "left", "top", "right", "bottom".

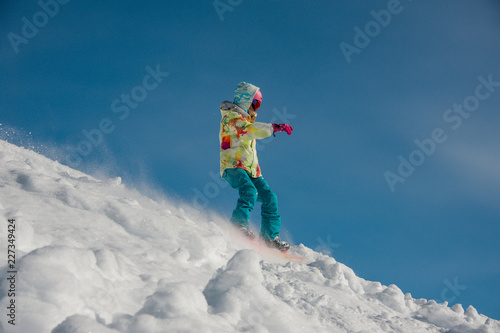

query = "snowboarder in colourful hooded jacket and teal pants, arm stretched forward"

[{"left": 219, "top": 82, "right": 293, "bottom": 251}]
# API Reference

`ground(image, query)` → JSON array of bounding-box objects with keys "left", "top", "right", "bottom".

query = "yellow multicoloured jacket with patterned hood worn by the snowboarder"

[{"left": 219, "top": 82, "right": 274, "bottom": 178}]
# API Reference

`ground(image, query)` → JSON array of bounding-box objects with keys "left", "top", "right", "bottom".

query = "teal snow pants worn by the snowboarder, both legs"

[{"left": 222, "top": 168, "right": 281, "bottom": 239}]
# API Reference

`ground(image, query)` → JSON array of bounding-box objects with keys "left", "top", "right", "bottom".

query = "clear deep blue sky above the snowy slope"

[{"left": 0, "top": 0, "right": 500, "bottom": 319}]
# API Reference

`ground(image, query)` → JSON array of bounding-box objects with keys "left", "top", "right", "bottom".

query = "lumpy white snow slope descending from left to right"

[{"left": 0, "top": 141, "right": 500, "bottom": 333}]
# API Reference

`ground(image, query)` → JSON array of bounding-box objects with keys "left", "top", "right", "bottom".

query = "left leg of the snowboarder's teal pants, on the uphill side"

[{"left": 223, "top": 168, "right": 257, "bottom": 228}]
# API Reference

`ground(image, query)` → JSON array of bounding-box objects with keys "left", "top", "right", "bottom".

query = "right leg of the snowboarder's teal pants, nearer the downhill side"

[{"left": 251, "top": 177, "right": 281, "bottom": 239}]
